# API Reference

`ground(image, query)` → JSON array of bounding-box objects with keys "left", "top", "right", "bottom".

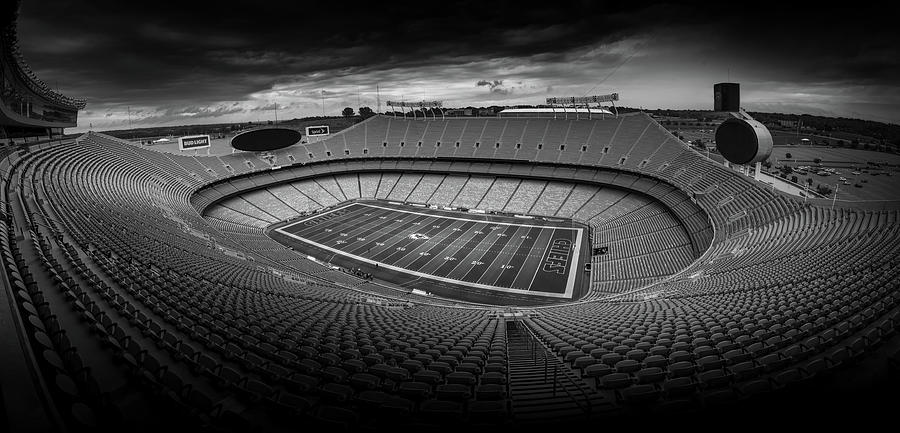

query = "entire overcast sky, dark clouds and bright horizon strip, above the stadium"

[{"left": 19, "top": 0, "right": 900, "bottom": 131}]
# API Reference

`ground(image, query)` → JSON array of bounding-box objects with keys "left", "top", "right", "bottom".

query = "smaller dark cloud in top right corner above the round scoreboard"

[{"left": 682, "top": 4, "right": 900, "bottom": 84}]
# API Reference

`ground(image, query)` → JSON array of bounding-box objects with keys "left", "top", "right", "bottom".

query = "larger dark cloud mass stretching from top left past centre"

[{"left": 20, "top": 0, "right": 684, "bottom": 103}]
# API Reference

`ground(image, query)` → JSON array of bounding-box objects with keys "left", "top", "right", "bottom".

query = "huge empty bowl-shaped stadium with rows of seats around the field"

[{"left": 0, "top": 0, "right": 900, "bottom": 431}]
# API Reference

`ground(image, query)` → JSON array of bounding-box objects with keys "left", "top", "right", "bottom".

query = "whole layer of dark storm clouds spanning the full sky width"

[{"left": 19, "top": 0, "right": 900, "bottom": 124}]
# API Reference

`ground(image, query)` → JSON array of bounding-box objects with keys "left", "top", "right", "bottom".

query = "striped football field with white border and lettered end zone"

[{"left": 274, "top": 202, "right": 586, "bottom": 299}]
